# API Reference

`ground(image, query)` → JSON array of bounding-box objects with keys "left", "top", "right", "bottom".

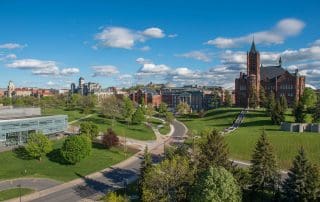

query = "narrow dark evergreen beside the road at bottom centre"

[{"left": 138, "top": 146, "right": 152, "bottom": 198}]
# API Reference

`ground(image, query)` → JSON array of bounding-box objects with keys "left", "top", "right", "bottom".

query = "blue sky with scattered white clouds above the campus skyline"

[{"left": 0, "top": 0, "right": 320, "bottom": 88}]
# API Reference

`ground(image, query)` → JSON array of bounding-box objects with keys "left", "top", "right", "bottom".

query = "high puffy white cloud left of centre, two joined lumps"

[{"left": 94, "top": 27, "right": 165, "bottom": 49}]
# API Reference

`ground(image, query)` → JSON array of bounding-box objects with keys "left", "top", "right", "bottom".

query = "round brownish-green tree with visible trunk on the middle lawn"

[{"left": 101, "top": 95, "right": 121, "bottom": 127}]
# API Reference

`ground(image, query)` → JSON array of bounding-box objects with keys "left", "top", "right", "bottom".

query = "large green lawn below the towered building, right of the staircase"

[{"left": 226, "top": 110, "right": 320, "bottom": 169}]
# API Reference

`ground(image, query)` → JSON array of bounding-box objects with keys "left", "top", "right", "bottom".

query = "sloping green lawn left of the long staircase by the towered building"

[{"left": 179, "top": 108, "right": 241, "bottom": 132}]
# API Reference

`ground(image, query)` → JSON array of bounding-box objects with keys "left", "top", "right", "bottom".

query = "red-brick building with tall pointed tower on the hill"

[{"left": 235, "top": 41, "right": 305, "bottom": 107}]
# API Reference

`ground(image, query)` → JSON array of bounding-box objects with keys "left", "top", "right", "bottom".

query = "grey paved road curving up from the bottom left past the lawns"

[{"left": 25, "top": 121, "right": 187, "bottom": 202}]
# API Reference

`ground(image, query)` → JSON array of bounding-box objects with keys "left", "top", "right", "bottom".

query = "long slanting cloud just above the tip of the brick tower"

[{"left": 205, "top": 18, "right": 305, "bottom": 48}]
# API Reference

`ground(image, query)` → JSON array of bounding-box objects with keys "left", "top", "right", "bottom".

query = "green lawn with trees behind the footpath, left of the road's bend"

[{"left": 74, "top": 114, "right": 156, "bottom": 140}]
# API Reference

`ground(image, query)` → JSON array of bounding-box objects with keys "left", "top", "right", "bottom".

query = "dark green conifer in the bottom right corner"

[{"left": 283, "top": 147, "right": 320, "bottom": 201}]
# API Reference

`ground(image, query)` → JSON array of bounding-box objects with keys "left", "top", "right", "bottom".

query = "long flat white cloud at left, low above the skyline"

[{"left": 6, "top": 59, "right": 79, "bottom": 76}]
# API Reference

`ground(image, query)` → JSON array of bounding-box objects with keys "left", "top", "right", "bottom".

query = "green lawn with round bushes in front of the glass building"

[{"left": 0, "top": 140, "right": 132, "bottom": 181}]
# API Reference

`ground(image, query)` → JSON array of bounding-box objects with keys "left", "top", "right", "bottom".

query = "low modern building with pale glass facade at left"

[{"left": 0, "top": 115, "right": 68, "bottom": 146}]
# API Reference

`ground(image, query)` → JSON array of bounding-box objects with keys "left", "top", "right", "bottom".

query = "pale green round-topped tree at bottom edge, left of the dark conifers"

[{"left": 191, "top": 167, "right": 241, "bottom": 202}]
